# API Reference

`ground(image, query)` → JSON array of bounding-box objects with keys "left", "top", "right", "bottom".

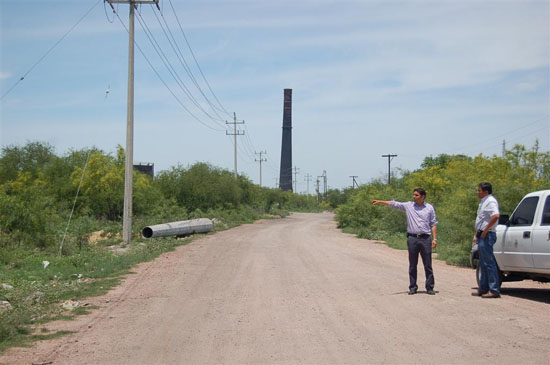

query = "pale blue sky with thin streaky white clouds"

[{"left": 0, "top": 0, "right": 550, "bottom": 193}]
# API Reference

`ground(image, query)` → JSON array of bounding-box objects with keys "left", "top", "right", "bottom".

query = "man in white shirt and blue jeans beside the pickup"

[{"left": 472, "top": 182, "right": 500, "bottom": 298}]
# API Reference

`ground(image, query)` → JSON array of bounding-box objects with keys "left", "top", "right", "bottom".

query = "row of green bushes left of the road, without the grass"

[{"left": 0, "top": 142, "right": 318, "bottom": 249}]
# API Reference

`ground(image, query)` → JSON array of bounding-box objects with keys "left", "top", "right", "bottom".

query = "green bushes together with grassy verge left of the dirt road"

[{"left": 0, "top": 142, "right": 320, "bottom": 352}]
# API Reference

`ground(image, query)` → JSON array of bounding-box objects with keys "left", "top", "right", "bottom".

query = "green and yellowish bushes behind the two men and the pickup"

[{"left": 336, "top": 143, "right": 550, "bottom": 266}]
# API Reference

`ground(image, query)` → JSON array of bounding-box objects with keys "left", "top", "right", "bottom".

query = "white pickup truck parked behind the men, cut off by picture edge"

[{"left": 470, "top": 190, "right": 550, "bottom": 284}]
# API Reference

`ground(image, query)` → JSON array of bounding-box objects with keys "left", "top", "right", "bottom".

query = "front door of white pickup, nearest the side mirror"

[{"left": 501, "top": 196, "right": 539, "bottom": 269}]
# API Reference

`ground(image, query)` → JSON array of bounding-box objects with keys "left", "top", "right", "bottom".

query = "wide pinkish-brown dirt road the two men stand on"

[{"left": 0, "top": 213, "right": 550, "bottom": 364}]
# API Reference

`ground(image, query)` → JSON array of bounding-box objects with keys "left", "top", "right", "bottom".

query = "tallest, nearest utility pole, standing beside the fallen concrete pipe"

[{"left": 108, "top": 0, "right": 160, "bottom": 244}]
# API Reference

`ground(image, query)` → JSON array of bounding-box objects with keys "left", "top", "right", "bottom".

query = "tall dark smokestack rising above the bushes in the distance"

[{"left": 279, "top": 89, "right": 292, "bottom": 191}]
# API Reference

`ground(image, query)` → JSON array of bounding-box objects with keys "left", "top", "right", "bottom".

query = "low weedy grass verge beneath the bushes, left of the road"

[{"left": 0, "top": 229, "right": 205, "bottom": 353}]
